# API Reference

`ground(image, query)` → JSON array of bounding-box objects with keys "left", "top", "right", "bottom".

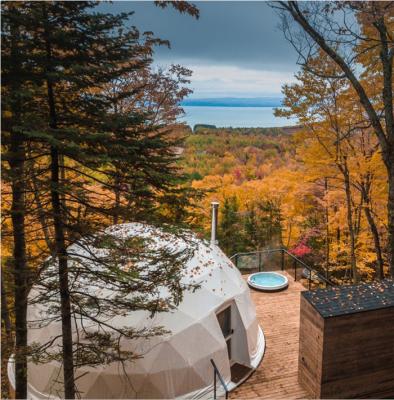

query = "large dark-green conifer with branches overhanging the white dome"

[{"left": 1, "top": 2, "right": 202, "bottom": 398}]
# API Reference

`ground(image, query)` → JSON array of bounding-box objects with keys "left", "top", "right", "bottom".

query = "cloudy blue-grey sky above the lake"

[{"left": 100, "top": 1, "right": 297, "bottom": 98}]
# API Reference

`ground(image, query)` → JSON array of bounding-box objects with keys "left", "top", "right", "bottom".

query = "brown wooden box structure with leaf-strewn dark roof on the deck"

[{"left": 298, "top": 280, "right": 394, "bottom": 398}]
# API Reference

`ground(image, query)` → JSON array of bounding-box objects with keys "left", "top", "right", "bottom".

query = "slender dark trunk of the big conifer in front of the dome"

[{"left": 42, "top": 4, "right": 75, "bottom": 399}]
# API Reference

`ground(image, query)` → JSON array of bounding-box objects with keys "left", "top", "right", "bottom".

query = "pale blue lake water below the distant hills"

[{"left": 181, "top": 106, "right": 297, "bottom": 128}]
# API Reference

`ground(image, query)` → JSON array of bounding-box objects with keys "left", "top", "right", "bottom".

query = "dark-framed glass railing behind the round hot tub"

[{"left": 230, "top": 248, "right": 335, "bottom": 290}]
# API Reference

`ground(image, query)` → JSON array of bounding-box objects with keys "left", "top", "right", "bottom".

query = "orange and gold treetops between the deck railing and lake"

[{"left": 181, "top": 125, "right": 388, "bottom": 283}]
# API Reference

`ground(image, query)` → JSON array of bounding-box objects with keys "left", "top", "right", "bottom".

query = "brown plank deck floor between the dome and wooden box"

[{"left": 230, "top": 275, "right": 309, "bottom": 399}]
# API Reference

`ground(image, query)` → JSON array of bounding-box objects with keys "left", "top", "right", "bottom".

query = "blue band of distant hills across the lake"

[{"left": 181, "top": 97, "right": 282, "bottom": 107}]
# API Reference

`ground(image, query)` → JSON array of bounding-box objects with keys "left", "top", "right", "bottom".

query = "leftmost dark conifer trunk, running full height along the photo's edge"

[{"left": 2, "top": 3, "right": 34, "bottom": 399}]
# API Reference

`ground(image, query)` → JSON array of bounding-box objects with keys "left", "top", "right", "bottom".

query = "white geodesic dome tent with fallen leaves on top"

[{"left": 8, "top": 223, "right": 265, "bottom": 399}]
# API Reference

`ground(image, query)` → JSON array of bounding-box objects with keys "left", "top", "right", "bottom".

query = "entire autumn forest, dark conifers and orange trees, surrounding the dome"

[{"left": 1, "top": 1, "right": 394, "bottom": 399}]
